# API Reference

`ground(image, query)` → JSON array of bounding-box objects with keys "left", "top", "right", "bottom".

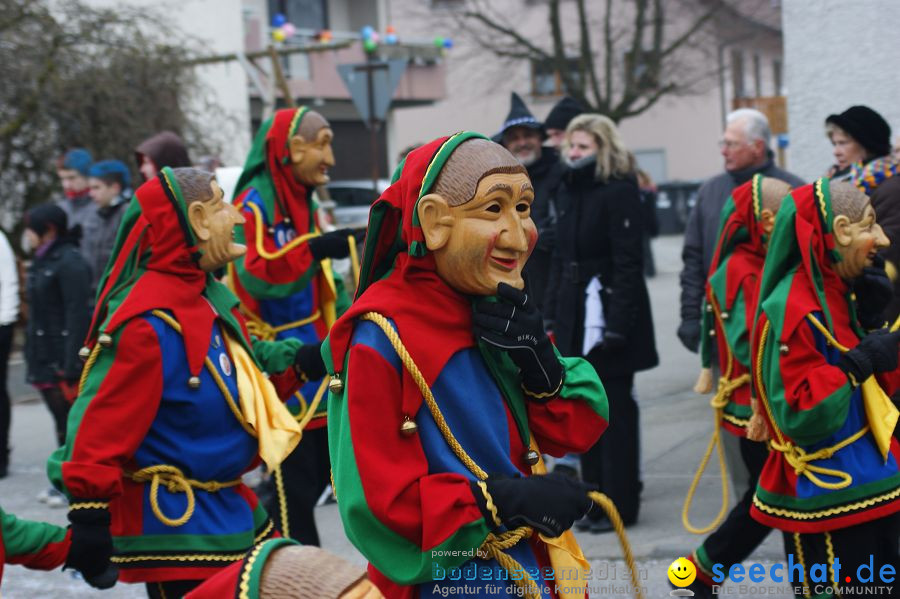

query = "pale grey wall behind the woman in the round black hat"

[{"left": 782, "top": 0, "right": 900, "bottom": 180}]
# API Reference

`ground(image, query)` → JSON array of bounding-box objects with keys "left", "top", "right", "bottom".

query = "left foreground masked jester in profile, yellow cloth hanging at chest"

[{"left": 48, "top": 168, "right": 310, "bottom": 584}]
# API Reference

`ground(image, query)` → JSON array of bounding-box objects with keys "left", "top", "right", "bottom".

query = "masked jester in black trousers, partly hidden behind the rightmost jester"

[{"left": 688, "top": 175, "right": 790, "bottom": 587}]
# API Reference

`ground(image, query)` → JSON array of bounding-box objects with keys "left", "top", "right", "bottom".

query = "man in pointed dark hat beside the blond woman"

[{"left": 491, "top": 92, "right": 562, "bottom": 308}]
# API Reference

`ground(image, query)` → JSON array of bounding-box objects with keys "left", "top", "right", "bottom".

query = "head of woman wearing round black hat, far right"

[{"left": 825, "top": 105, "right": 891, "bottom": 180}]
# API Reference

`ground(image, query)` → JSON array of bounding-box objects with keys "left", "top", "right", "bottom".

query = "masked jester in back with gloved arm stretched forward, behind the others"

[{"left": 229, "top": 107, "right": 349, "bottom": 545}]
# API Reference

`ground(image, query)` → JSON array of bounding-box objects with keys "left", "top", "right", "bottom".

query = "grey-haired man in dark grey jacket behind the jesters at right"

[{"left": 678, "top": 108, "right": 803, "bottom": 353}]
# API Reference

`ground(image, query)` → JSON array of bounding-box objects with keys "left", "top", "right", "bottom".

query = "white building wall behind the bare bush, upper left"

[{"left": 87, "top": 0, "right": 251, "bottom": 165}]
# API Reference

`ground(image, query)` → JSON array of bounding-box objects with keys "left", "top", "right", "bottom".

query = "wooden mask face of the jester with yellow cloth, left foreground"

[{"left": 188, "top": 181, "right": 247, "bottom": 272}]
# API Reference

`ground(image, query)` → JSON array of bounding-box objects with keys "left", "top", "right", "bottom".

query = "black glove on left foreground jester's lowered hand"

[{"left": 64, "top": 499, "right": 119, "bottom": 589}]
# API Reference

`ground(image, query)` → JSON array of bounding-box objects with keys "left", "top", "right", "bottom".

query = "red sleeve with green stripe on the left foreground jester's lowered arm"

[{"left": 62, "top": 318, "right": 163, "bottom": 499}]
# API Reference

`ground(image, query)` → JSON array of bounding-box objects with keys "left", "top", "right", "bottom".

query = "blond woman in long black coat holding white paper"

[{"left": 545, "top": 114, "right": 659, "bottom": 532}]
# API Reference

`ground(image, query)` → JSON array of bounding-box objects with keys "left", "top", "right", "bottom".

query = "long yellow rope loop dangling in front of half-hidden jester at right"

[{"left": 681, "top": 297, "right": 750, "bottom": 535}]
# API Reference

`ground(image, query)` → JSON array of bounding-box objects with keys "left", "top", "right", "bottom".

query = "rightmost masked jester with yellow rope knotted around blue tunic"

[{"left": 751, "top": 179, "right": 900, "bottom": 596}]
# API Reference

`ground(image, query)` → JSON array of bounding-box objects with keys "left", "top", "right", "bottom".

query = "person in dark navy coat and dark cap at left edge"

[{"left": 25, "top": 203, "right": 91, "bottom": 445}]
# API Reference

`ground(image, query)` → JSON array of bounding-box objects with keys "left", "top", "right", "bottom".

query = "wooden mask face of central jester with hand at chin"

[{"left": 418, "top": 173, "right": 537, "bottom": 295}]
